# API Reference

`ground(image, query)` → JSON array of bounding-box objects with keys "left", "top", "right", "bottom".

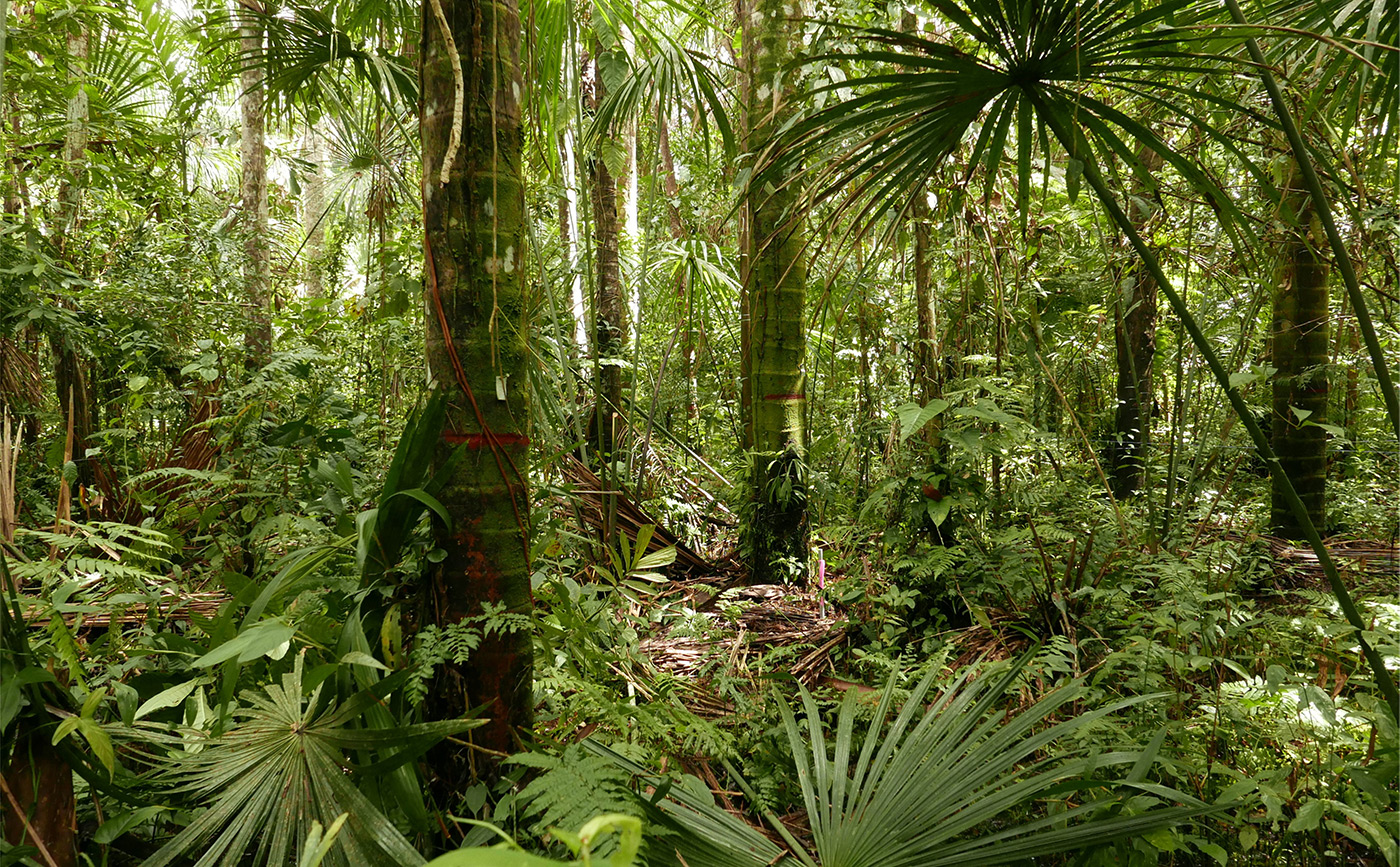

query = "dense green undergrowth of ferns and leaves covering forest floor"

[{"left": 0, "top": 351, "right": 1400, "bottom": 866}]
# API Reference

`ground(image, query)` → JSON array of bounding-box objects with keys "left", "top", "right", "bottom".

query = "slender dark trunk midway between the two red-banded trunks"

[{"left": 588, "top": 38, "right": 627, "bottom": 459}]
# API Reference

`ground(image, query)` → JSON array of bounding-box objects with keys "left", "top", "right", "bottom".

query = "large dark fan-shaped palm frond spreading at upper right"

[{"left": 778, "top": 0, "right": 1271, "bottom": 243}]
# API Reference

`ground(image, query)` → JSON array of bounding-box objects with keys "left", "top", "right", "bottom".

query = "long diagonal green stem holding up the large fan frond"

[{"left": 1041, "top": 101, "right": 1400, "bottom": 719}]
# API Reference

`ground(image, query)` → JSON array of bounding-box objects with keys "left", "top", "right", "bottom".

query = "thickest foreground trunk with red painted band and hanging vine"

[{"left": 421, "top": 0, "right": 533, "bottom": 791}]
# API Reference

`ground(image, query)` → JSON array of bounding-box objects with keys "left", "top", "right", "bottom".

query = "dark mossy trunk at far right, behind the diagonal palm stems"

[{"left": 1271, "top": 156, "right": 1330, "bottom": 539}]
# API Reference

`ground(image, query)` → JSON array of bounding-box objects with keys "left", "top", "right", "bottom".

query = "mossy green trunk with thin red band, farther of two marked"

[{"left": 739, "top": 0, "right": 808, "bottom": 583}]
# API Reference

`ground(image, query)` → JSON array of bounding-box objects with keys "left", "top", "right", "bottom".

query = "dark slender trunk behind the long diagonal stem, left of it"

[{"left": 1109, "top": 150, "right": 1162, "bottom": 497}]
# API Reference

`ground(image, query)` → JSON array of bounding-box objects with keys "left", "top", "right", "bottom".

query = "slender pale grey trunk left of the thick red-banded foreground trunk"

[{"left": 238, "top": 11, "right": 272, "bottom": 370}]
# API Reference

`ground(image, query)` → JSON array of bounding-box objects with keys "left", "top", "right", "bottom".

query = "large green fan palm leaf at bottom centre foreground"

[{"left": 596, "top": 658, "right": 1215, "bottom": 867}]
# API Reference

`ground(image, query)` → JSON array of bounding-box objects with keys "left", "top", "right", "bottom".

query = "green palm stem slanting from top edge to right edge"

[{"left": 1225, "top": 0, "right": 1400, "bottom": 440}]
